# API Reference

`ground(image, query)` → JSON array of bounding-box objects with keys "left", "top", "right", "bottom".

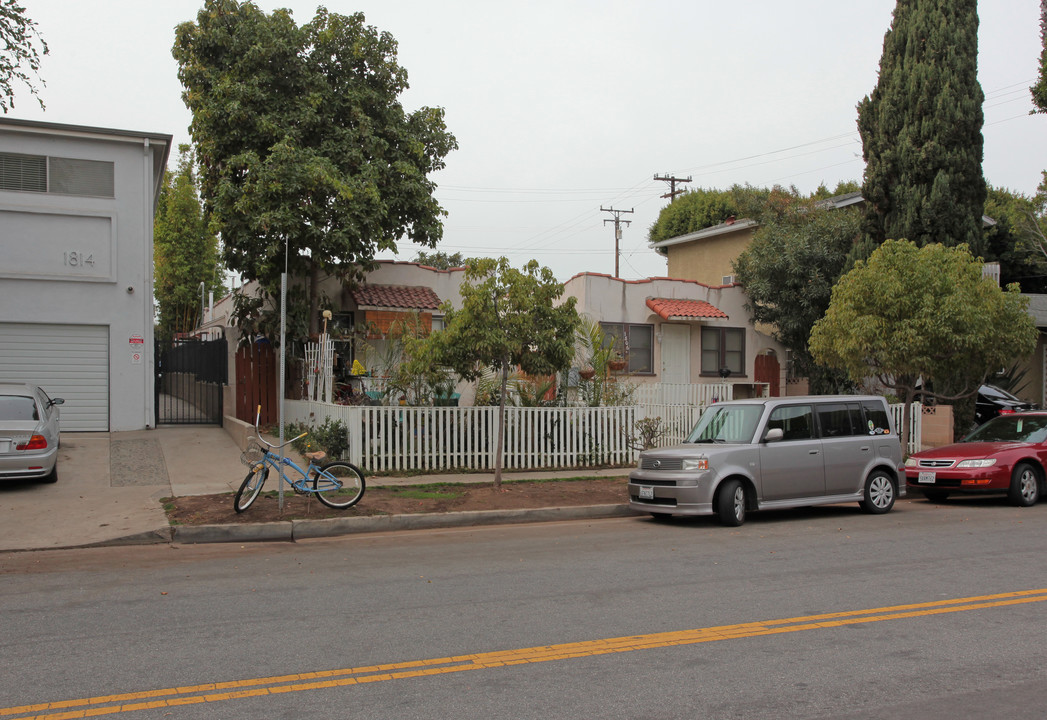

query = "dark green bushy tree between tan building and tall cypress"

[{"left": 734, "top": 199, "right": 862, "bottom": 392}]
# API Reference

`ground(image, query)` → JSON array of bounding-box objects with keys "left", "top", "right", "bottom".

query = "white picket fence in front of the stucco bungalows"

[{"left": 286, "top": 393, "right": 923, "bottom": 472}]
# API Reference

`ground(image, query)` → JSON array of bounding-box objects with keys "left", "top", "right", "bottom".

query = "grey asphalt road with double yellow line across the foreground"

[{"left": 6, "top": 493, "right": 1047, "bottom": 720}]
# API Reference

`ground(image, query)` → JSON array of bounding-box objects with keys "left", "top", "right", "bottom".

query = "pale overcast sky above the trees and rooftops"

[{"left": 8, "top": 0, "right": 1047, "bottom": 280}]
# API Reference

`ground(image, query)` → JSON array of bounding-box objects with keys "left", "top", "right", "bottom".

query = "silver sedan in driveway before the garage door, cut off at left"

[{"left": 0, "top": 383, "right": 65, "bottom": 482}]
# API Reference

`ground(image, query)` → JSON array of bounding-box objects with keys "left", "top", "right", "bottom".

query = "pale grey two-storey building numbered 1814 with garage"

[{"left": 0, "top": 117, "right": 171, "bottom": 431}]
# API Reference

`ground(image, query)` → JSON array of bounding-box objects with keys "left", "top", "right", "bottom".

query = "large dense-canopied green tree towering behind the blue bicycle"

[{"left": 173, "top": 0, "right": 458, "bottom": 332}]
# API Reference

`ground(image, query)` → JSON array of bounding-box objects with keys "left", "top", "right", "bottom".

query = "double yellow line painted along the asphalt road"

[{"left": 8, "top": 588, "right": 1047, "bottom": 720}]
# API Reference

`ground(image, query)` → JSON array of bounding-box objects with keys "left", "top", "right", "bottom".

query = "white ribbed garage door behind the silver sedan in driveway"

[{"left": 0, "top": 322, "right": 109, "bottom": 431}]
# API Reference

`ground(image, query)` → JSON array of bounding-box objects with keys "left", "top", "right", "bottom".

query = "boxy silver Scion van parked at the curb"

[{"left": 629, "top": 396, "right": 906, "bottom": 525}]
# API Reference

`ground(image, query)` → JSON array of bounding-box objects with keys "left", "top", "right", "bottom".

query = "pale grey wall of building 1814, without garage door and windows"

[{"left": 0, "top": 119, "right": 170, "bottom": 430}]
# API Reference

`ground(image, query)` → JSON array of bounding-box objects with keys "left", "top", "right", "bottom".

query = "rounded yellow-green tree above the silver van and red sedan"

[{"left": 809, "top": 240, "right": 1037, "bottom": 456}]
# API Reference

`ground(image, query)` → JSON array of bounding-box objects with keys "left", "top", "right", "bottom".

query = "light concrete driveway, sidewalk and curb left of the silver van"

[{"left": 0, "top": 426, "right": 627, "bottom": 552}]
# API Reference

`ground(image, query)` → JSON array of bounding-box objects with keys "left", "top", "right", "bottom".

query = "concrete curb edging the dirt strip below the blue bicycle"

[{"left": 167, "top": 504, "right": 636, "bottom": 545}]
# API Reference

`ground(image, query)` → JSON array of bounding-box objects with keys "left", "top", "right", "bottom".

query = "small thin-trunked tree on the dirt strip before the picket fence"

[{"left": 430, "top": 257, "right": 578, "bottom": 488}]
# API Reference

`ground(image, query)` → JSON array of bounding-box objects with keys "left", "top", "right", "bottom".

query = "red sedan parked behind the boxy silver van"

[{"left": 906, "top": 410, "right": 1047, "bottom": 507}]
